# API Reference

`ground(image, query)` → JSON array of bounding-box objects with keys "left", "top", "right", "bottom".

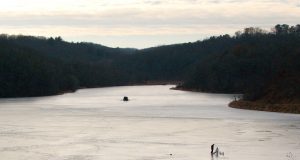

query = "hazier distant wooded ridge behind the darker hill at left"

[{"left": 1, "top": 34, "right": 137, "bottom": 62}]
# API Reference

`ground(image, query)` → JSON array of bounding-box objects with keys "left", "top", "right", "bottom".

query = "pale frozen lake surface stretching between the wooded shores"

[{"left": 0, "top": 85, "right": 300, "bottom": 160}]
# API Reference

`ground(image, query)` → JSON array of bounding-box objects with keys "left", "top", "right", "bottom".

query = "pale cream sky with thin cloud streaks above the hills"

[{"left": 0, "top": 0, "right": 300, "bottom": 48}]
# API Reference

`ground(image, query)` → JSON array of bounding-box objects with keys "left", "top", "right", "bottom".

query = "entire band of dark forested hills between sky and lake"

[{"left": 0, "top": 24, "right": 300, "bottom": 109}]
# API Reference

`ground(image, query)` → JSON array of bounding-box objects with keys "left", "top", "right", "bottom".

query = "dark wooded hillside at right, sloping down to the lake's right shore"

[{"left": 182, "top": 24, "right": 300, "bottom": 103}]
